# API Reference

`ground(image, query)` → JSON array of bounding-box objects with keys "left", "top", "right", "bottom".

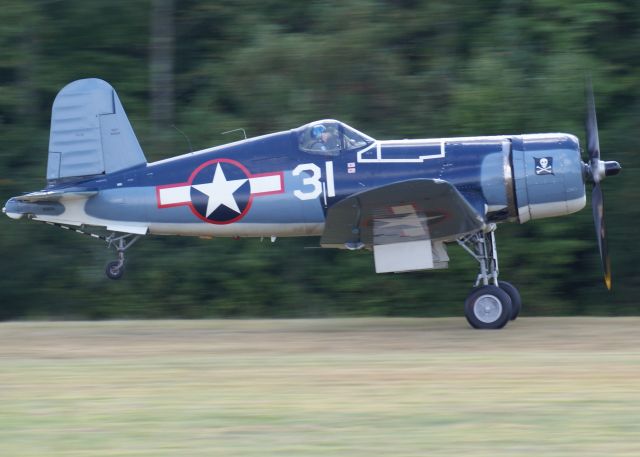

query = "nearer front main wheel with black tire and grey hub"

[{"left": 464, "top": 286, "right": 511, "bottom": 329}]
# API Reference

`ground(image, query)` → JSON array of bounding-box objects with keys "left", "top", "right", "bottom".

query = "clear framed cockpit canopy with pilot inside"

[{"left": 296, "top": 119, "right": 374, "bottom": 156}]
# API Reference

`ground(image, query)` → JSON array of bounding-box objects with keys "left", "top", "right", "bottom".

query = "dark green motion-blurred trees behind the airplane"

[{"left": 0, "top": 0, "right": 640, "bottom": 319}]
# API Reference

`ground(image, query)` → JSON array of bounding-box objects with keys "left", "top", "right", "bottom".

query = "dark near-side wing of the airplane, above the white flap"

[{"left": 320, "top": 179, "right": 485, "bottom": 248}]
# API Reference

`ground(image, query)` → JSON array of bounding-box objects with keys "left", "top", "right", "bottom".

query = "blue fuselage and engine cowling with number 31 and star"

[{"left": 7, "top": 121, "right": 584, "bottom": 236}]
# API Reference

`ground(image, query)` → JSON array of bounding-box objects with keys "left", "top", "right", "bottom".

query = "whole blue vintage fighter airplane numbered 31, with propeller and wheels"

[{"left": 3, "top": 79, "right": 620, "bottom": 329}]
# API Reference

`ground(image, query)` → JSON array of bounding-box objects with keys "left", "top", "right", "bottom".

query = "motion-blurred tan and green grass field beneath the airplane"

[{"left": 0, "top": 318, "right": 640, "bottom": 457}]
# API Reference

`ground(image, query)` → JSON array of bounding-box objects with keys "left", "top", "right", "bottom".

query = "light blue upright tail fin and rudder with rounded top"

[{"left": 47, "top": 78, "right": 146, "bottom": 181}]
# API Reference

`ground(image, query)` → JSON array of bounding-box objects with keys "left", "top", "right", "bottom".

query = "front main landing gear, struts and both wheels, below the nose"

[{"left": 458, "top": 227, "right": 522, "bottom": 329}]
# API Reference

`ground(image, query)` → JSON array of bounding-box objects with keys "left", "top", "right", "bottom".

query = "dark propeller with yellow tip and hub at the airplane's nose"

[{"left": 584, "top": 79, "right": 622, "bottom": 290}]
